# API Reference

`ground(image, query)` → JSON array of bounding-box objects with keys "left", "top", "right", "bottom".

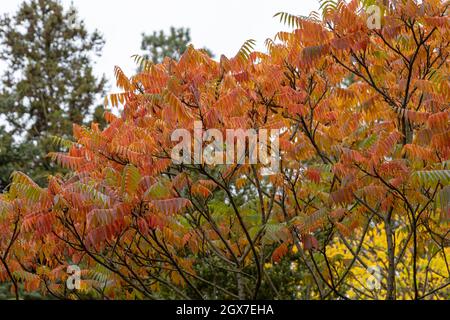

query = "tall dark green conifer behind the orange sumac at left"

[{"left": 0, "top": 0, "right": 105, "bottom": 189}]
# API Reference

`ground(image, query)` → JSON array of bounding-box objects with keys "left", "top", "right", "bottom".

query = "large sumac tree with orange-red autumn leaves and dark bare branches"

[{"left": 0, "top": 0, "right": 450, "bottom": 299}]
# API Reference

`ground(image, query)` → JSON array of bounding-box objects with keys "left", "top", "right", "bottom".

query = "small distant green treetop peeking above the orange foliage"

[{"left": 141, "top": 27, "right": 213, "bottom": 63}]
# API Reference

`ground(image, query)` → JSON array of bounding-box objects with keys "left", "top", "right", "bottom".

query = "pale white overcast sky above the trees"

[{"left": 0, "top": 0, "right": 319, "bottom": 90}]
